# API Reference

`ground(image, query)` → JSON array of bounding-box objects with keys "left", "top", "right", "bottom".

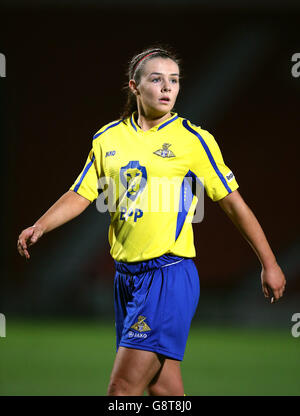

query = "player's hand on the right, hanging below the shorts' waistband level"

[{"left": 261, "top": 263, "right": 286, "bottom": 303}]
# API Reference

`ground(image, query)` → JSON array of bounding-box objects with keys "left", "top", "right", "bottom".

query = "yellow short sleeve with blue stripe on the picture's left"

[{"left": 70, "top": 141, "right": 101, "bottom": 202}]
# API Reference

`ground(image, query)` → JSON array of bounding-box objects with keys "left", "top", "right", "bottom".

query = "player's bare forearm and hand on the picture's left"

[{"left": 17, "top": 191, "right": 91, "bottom": 259}]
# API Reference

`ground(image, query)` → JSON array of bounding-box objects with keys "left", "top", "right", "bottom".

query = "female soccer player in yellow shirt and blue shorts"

[{"left": 18, "top": 48, "right": 285, "bottom": 396}]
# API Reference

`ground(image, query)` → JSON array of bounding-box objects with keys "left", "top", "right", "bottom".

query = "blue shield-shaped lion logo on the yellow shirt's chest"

[{"left": 120, "top": 160, "right": 147, "bottom": 201}]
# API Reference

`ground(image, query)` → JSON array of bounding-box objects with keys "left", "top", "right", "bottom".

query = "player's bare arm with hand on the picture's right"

[{"left": 218, "top": 190, "right": 286, "bottom": 303}]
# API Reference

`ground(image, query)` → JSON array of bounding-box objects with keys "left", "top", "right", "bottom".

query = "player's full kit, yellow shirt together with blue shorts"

[{"left": 70, "top": 113, "right": 238, "bottom": 360}]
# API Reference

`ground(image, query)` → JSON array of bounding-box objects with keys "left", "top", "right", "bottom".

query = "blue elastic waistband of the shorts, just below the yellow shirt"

[{"left": 115, "top": 254, "right": 185, "bottom": 274}]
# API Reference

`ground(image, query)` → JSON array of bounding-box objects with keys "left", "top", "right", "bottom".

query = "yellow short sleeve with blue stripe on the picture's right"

[{"left": 192, "top": 129, "right": 239, "bottom": 201}]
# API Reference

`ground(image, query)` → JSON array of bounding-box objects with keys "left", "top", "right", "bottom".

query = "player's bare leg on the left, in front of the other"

[{"left": 107, "top": 347, "right": 165, "bottom": 396}]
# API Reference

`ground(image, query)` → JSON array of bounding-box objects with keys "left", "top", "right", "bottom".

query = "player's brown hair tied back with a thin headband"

[{"left": 120, "top": 46, "right": 180, "bottom": 120}]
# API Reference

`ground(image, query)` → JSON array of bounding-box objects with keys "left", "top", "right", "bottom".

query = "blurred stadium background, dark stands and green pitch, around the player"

[{"left": 0, "top": 0, "right": 300, "bottom": 395}]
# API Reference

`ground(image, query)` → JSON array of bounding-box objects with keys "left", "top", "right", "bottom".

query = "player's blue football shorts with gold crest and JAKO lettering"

[{"left": 114, "top": 254, "right": 200, "bottom": 361}]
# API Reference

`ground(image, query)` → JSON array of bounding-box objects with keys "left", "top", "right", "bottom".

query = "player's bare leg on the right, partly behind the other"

[{"left": 147, "top": 358, "right": 184, "bottom": 396}]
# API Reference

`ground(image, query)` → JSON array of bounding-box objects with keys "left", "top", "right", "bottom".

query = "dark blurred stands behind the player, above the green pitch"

[{"left": 0, "top": 1, "right": 300, "bottom": 328}]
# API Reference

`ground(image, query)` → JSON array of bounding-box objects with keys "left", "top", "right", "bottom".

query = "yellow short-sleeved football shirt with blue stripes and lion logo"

[{"left": 70, "top": 113, "right": 238, "bottom": 262}]
